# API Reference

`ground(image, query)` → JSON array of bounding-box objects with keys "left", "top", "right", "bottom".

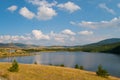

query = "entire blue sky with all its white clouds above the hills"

[{"left": 0, "top": 0, "right": 120, "bottom": 46}]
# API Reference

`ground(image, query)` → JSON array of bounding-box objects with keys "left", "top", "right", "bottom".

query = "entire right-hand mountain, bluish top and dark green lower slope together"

[{"left": 81, "top": 38, "right": 120, "bottom": 54}]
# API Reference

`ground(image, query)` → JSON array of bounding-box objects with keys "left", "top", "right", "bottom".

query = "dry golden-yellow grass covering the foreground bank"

[{"left": 0, "top": 63, "right": 120, "bottom": 80}]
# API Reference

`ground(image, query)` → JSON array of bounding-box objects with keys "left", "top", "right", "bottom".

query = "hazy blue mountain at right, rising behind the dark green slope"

[{"left": 84, "top": 38, "right": 120, "bottom": 46}]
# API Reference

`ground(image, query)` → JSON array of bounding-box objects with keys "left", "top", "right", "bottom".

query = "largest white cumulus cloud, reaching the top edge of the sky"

[{"left": 28, "top": 0, "right": 57, "bottom": 20}]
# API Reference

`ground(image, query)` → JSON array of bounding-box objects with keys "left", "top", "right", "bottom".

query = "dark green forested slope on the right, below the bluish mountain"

[{"left": 81, "top": 42, "right": 120, "bottom": 54}]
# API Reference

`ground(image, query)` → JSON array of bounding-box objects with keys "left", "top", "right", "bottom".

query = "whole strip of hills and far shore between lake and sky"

[{"left": 0, "top": 38, "right": 120, "bottom": 54}]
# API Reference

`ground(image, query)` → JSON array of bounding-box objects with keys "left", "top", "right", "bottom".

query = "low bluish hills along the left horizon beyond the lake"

[{"left": 0, "top": 43, "right": 38, "bottom": 48}]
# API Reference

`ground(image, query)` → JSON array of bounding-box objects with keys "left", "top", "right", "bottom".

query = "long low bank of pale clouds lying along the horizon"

[{"left": 0, "top": 29, "right": 113, "bottom": 46}]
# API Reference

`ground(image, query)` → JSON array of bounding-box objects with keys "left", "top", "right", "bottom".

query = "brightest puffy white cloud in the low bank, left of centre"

[{"left": 32, "top": 30, "right": 50, "bottom": 40}]
